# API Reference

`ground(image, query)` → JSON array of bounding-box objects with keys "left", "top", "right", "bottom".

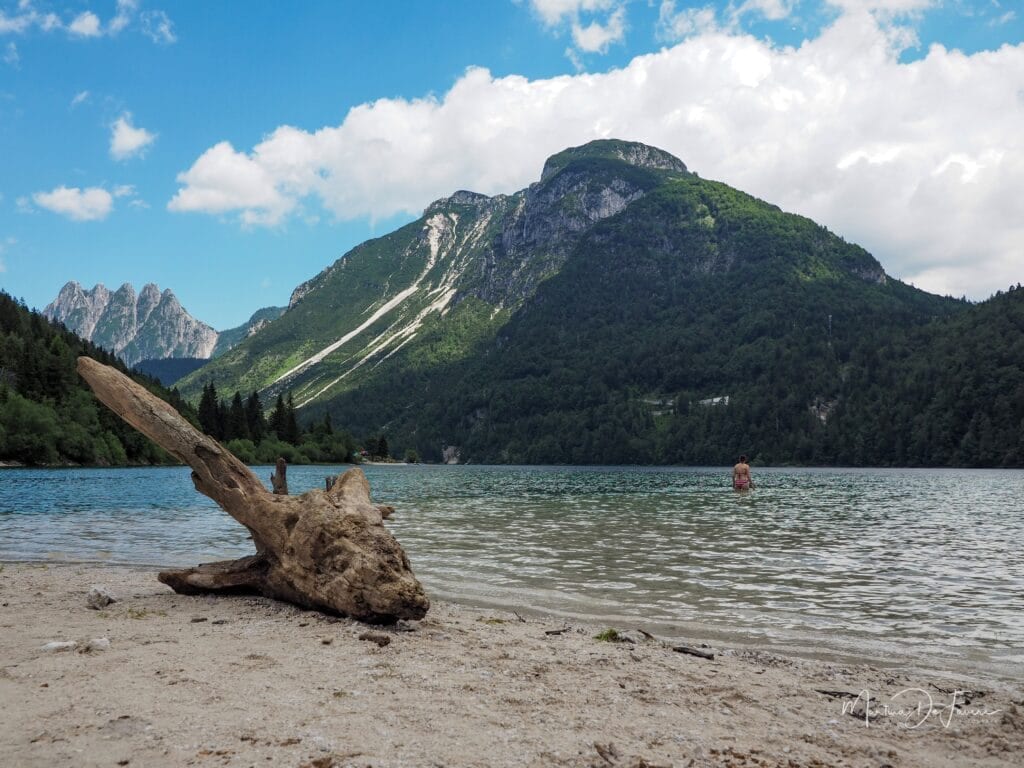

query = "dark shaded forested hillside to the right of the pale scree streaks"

[{"left": 313, "top": 171, "right": 1024, "bottom": 466}]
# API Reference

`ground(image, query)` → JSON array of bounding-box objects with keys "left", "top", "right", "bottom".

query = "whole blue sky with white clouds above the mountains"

[{"left": 0, "top": 0, "right": 1024, "bottom": 330}]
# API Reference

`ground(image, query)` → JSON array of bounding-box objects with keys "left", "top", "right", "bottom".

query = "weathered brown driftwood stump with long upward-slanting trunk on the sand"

[{"left": 78, "top": 357, "right": 430, "bottom": 624}]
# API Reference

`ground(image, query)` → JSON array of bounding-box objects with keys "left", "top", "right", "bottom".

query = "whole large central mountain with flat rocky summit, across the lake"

[{"left": 180, "top": 140, "right": 1024, "bottom": 464}]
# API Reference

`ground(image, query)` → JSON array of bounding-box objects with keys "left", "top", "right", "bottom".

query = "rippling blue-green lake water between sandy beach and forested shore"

[{"left": 0, "top": 466, "right": 1024, "bottom": 672}]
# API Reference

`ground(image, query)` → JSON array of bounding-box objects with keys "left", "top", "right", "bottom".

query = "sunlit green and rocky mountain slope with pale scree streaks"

[{"left": 180, "top": 141, "right": 686, "bottom": 406}]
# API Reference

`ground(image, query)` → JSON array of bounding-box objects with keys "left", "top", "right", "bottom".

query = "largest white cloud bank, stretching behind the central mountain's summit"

[{"left": 169, "top": 12, "right": 1024, "bottom": 297}]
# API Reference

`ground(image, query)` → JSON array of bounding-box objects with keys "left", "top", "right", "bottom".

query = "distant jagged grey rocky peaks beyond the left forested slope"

[{"left": 43, "top": 282, "right": 284, "bottom": 370}]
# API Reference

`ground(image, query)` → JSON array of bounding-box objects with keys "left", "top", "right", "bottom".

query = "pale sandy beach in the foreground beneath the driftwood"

[{"left": 0, "top": 563, "right": 1024, "bottom": 768}]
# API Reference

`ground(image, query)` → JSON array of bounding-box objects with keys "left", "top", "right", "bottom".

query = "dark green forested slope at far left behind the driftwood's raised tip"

[{"left": 0, "top": 292, "right": 188, "bottom": 466}]
